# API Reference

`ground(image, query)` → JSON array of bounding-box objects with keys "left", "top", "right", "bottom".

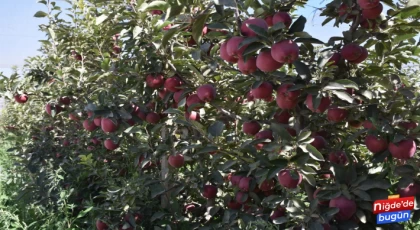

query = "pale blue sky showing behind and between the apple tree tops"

[{"left": 0, "top": 0, "right": 388, "bottom": 76}]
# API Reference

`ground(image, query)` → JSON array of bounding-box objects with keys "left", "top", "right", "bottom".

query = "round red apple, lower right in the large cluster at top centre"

[{"left": 271, "top": 39, "right": 299, "bottom": 64}]
